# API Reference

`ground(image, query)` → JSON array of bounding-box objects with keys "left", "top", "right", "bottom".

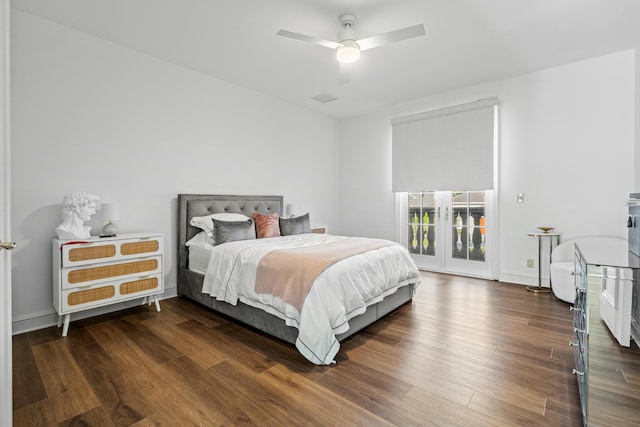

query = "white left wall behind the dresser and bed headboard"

[{"left": 11, "top": 10, "right": 338, "bottom": 333}]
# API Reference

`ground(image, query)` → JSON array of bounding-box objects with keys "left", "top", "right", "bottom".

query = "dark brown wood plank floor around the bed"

[{"left": 13, "top": 273, "right": 582, "bottom": 426}]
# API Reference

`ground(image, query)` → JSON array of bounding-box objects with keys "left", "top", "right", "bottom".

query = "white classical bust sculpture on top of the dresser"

[{"left": 56, "top": 192, "right": 100, "bottom": 240}]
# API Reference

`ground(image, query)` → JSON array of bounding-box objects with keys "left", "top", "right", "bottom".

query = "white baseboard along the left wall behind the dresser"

[{"left": 11, "top": 286, "right": 178, "bottom": 335}]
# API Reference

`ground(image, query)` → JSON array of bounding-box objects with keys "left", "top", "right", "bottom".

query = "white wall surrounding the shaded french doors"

[{"left": 339, "top": 51, "right": 640, "bottom": 284}]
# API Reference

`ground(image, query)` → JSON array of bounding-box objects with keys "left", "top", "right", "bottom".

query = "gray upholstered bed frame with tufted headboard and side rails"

[{"left": 178, "top": 194, "right": 414, "bottom": 344}]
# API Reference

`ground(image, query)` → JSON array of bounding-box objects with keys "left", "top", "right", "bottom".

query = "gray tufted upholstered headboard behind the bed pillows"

[{"left": 178, "top": 194, "right": 283, "bottom": 268}]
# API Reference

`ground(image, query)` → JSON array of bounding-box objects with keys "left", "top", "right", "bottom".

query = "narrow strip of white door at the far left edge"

[{"left": 0, "top": 0, "right": 13, "bottom": 426}]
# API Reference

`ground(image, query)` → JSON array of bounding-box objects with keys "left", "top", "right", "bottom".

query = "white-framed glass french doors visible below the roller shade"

[{"left": 401, "top": 191, "right": 494, "bottom": 278}]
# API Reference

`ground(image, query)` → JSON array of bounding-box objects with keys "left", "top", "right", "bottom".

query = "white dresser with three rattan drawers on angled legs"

[{"left": 52, "top": 233, "right": 164, "bottom": 337}]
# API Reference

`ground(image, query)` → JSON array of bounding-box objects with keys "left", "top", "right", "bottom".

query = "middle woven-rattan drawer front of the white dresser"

[{"left": 62, "top": 257, "right": 161, "bottom": 288}]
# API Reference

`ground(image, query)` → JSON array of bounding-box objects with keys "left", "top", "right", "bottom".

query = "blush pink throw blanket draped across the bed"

[{"left": 255, "top": 237, "right": 393, "bottom": 311}]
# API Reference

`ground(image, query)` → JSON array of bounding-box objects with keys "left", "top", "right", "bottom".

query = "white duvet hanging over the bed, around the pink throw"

[{"left": 202, "top": 234, "right": 420, "bottom": 365}]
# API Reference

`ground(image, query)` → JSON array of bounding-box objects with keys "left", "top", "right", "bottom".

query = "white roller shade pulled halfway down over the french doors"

[{"left": 391, "top": 98, "right": 498, "bottom": 192}]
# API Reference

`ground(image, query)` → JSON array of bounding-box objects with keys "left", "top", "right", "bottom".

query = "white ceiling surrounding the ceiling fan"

[{"left": 11, "top": 0, "right": 640, "bottom": 118}]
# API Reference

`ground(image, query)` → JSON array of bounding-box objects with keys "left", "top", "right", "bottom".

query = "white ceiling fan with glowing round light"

[{"left": 276, "top": 12, "right": 425, "bottom": 84}]
